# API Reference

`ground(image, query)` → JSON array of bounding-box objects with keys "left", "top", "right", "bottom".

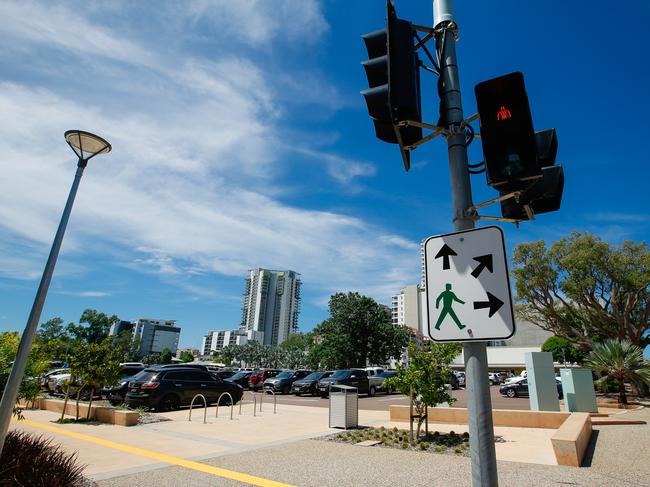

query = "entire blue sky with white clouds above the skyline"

[{"left": 0, "top": 0, "right": 650, "bottom": 346}]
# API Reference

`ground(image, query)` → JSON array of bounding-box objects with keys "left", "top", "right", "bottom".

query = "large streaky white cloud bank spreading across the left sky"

[{"left": 0, "top": 2, "right": 419, "bottom": 310}]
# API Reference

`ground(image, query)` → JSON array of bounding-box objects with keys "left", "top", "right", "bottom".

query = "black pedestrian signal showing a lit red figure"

[{"left": 474, "top": 72, "right": 542, "bottom": 191}]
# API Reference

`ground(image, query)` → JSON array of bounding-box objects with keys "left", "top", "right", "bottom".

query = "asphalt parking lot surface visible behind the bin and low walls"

[{"left": 256, "top": 386, "right": 530, "bottom": 411}]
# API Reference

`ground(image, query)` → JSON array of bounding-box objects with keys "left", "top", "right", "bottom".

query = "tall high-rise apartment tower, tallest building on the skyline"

[{"left": 240, "top": 268, "right": 302, "bottom": 345}]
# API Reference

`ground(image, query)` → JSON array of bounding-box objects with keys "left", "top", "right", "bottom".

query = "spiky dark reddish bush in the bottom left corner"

[{"left": 0, "top": 430, "right": 86, "bottom": 487}]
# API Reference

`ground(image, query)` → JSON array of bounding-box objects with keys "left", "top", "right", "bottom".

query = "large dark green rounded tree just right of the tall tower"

[{"left": 309, "top": 292, "right": 409, "bottom": 368}]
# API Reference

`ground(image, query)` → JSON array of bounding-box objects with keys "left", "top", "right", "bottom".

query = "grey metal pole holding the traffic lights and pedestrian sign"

[{"left": 433, "top": 0, "right": 498, "bottom": 487}]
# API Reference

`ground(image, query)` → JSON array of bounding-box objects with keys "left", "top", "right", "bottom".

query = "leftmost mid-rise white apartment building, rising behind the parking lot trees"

[{"left": 109, "top": 318, "right": 181, "bottom": 357}]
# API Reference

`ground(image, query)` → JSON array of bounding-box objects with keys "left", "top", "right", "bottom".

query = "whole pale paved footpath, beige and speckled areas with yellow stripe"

[{"left": 12, "top": 405, "right": 650, "bottom": 487}]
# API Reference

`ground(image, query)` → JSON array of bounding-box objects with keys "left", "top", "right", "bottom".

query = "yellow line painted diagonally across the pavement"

[{"left": 12, "top": 419, "right": 293, "bottom": 487}]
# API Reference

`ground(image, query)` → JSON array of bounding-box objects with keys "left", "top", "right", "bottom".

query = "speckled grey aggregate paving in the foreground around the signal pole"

[{"left": 99, "top": 409, "right": 650, "bottom": 487}]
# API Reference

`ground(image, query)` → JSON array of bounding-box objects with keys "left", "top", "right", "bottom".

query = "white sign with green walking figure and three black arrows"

[{"left": 424, "top": 226, "right": 515, "bottom": 342}]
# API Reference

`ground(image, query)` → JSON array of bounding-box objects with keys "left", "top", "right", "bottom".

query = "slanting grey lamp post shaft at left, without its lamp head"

[{"left": 0, "top": 159, "right": 87, "bottom": 453}]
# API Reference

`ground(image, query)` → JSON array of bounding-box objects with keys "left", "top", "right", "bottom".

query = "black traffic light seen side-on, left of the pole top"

[{"left": 361, "top": 0, "right": 422, "bottom": 171}]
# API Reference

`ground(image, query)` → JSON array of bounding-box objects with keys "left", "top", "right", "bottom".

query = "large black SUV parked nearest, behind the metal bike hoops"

[{"left": 126, "top": 366, "right": 244, "bottom": 411}]
